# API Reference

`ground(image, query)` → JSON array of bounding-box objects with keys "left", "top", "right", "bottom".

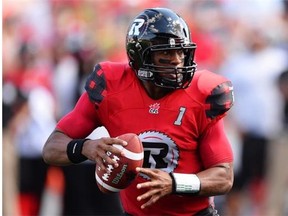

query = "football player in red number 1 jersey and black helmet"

[{"left": 43, "top": 8, "right": 233, "bottom": 215}]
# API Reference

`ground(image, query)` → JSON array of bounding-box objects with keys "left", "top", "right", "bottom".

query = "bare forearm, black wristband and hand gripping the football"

[{"left": 43, "top": 129, "right": 127, "bottom": 169}]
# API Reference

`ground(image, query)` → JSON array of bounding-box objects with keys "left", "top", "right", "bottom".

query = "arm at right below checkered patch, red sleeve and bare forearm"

[{"left": 197, "top": 120, "right": 234, "bottom": 196}]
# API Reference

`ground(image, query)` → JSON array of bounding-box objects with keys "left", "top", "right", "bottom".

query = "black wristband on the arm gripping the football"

[{"left": 66, "top": 139, "right": 89, "bottom": 164}]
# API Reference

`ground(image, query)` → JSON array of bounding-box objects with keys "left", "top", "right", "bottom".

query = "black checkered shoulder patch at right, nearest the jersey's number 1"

[{"left": 205, "top": 81, "right": 234, "bottom": 119}]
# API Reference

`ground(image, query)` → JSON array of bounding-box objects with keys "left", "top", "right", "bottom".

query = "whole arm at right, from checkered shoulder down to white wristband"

[{"left": 191, "top": 74, "right": 234, "bottom": 196}]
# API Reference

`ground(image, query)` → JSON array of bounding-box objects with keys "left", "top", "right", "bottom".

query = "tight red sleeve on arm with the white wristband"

[{"left": 200, "top": 120, "right": 233, "bottom": 168}]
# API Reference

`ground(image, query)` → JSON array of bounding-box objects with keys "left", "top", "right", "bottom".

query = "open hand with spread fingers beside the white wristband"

[{"left": 136, "top": 167, "right": 172, "bottom": 209}]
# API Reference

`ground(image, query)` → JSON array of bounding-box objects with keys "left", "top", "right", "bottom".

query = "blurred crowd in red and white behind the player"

[{"left": 2, "top": 0, "right": 288, "bottom": 216}]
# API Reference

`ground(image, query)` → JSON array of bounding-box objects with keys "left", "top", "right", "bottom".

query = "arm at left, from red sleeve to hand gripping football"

[{"left": 43, "top": 93, "right": 126, "bottom": 169}]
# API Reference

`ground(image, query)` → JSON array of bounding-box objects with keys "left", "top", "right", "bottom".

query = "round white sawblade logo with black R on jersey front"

[{"left": 139, "top": 131, "right": 179, "bottom": 179}]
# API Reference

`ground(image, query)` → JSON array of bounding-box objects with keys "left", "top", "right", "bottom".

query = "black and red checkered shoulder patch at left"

[{"left": 85, "top": 64, "right": 106, "bottom": 106}]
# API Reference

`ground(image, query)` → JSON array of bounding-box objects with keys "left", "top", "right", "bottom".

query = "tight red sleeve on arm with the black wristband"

[{"left": 56, "top": 92, "right": 101, "bottom": 139}]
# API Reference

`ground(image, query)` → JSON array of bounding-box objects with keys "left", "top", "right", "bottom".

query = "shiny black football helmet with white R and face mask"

[{"left": 126, "top": 8, "right": 196, "bottom": 89}]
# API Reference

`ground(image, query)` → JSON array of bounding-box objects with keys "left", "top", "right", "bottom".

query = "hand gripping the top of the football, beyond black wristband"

[{"left": 82, "top": 137, "right": 127, "bottom": 169}]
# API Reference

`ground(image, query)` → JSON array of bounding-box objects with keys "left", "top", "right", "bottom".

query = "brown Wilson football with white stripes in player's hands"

[{"left": 95, "top": 133, "right": 144, "bottom": 193}]
